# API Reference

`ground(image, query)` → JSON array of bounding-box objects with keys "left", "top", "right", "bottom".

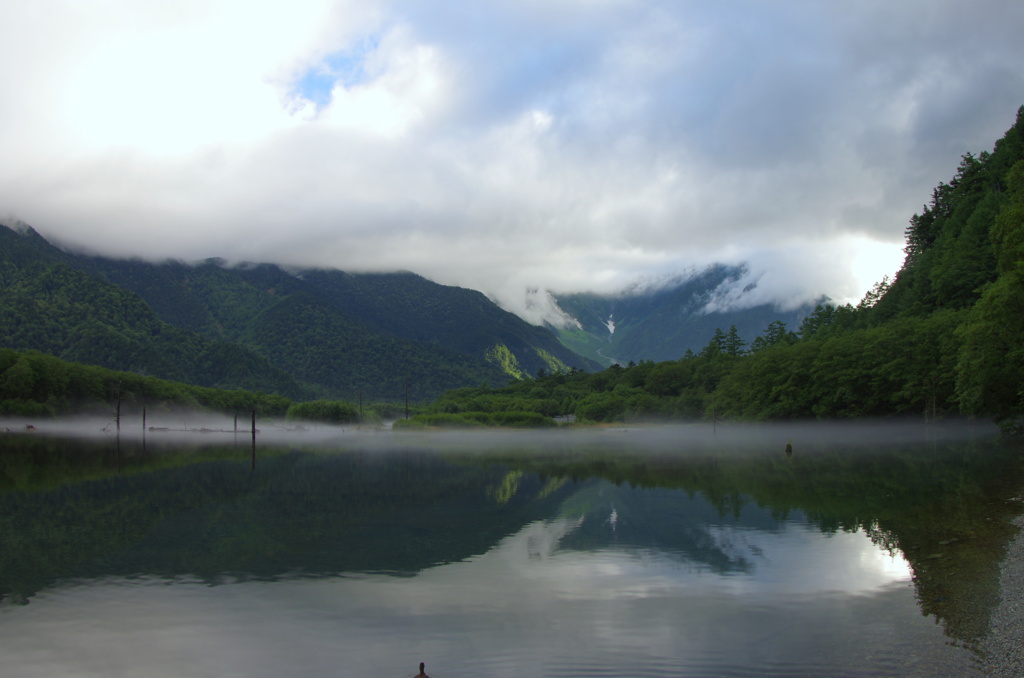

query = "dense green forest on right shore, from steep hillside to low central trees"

[{"left": 403, "top": 107, "right": 1024, "bottom": 431}]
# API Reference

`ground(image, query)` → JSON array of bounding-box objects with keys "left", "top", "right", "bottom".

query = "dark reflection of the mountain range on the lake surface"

[{"left": 0, "top": 442, "right": 794, "bottom": 597}]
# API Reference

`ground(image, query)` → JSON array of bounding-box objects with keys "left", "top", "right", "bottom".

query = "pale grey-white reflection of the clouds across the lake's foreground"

[{"left": 0, "top": 517, "right": 942, "bottom": 678}]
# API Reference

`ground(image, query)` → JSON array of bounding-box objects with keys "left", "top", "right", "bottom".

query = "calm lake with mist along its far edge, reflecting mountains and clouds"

[{"left": 0, "top": 421, "right": 1024, "bottom": 678}]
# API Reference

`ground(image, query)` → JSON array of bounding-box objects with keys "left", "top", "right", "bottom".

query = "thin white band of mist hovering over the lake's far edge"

[{"left": 0, "top": 412, "right": 998, "bottom": 452}]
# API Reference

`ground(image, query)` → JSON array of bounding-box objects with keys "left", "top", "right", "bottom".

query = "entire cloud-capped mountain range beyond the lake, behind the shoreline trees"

[{"left": 0, "top": 224, "right": 806, "bottom": 401}]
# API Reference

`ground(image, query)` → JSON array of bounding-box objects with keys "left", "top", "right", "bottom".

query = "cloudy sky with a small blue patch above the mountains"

[{"left": 0, "top": 0, "right": 1024, "bottom": 322}]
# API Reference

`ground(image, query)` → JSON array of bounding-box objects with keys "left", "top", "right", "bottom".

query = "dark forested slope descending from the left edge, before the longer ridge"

[{"left": 0, "top": 227, "right": 302, "bottom": 396}]
